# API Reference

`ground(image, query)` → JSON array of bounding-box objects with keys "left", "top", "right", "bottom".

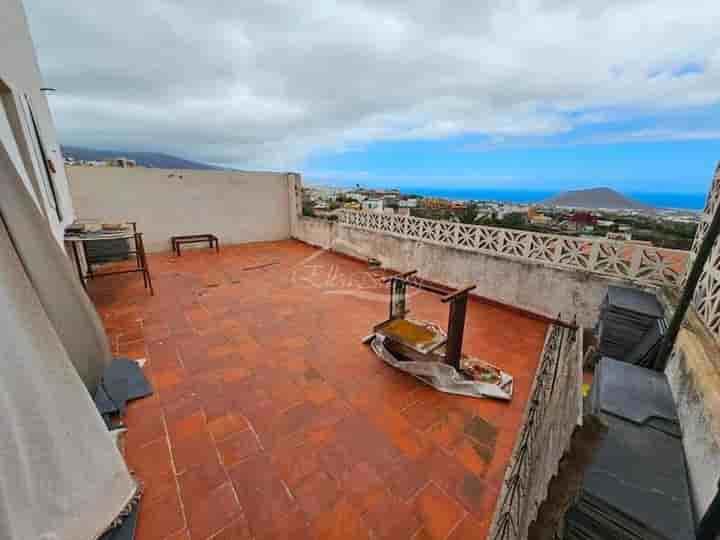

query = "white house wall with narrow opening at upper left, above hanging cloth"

[{"left": 0, "top": 0, "right": 74, "bottom": 241}]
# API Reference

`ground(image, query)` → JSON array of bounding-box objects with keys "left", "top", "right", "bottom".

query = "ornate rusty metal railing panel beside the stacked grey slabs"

[{"left": 489, "top": 324, "right": 582, "bottom": 540}]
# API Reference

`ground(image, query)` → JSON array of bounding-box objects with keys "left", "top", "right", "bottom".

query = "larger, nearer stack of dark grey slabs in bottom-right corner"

[{"left": 565, "top": 358, "right": 694, "bottom": 540}]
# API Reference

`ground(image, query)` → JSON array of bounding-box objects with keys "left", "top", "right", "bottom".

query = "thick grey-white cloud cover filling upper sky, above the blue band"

[{"left": 26, "top": 0, "right": 720, "bottom": 169}]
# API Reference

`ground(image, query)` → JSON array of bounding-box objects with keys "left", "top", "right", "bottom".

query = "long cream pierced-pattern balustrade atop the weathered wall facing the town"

[{"left": 339, "top": 210, "right": 689, "bottom": 286}]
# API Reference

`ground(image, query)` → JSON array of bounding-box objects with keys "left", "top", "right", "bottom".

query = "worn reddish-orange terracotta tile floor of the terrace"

[{"left": 90, "top": 241, "right": 546, "bottom": 540}]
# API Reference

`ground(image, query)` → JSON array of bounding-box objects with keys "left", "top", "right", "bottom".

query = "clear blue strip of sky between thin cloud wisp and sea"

[{"left": 303, "top": 134, "right": 720, "bottom": 193}]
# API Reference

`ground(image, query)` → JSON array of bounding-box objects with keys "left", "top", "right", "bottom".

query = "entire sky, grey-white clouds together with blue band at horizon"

[{"left": 24, "top": 0, "right": 720, "bottom": 192}]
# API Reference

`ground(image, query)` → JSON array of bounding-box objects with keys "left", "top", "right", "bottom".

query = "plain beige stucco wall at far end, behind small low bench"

[{"left": 67, "top": 167, "right": 290, "bottom": 251}]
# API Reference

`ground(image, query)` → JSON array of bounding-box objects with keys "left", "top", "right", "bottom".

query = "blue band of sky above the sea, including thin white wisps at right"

[{"left": 304, "top": 103, "right": 720, "bottom": 194}]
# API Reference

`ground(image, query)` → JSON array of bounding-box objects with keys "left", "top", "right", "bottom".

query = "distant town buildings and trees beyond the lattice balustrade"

[{"left": 303, "top": 182, "right": 701, "bottom": 249}]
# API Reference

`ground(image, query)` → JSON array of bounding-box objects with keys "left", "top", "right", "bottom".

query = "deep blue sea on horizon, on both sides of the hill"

[{"left": 401, "top": 186, "right": 705, "bottom": 210}]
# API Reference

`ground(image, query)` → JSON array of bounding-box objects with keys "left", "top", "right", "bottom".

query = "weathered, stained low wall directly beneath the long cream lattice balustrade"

[{"left": 293, "top": 217, "right": 640, "bottom": 327}]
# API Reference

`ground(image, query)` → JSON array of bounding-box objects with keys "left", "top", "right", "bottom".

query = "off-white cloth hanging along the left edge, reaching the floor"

[{"left": 0, "top": 145, "right": 137, "bottom": 540}]
